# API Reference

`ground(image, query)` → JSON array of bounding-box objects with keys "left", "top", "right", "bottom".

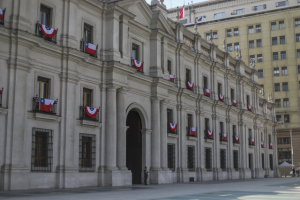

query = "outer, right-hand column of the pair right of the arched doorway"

[{"left": 160, "top": 101, "right": 168, "bottom": 170}]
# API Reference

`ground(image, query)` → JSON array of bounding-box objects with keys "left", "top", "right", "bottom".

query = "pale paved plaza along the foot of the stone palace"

[{"left": 0, "top": 178, "right": 300, "bottom": 200}]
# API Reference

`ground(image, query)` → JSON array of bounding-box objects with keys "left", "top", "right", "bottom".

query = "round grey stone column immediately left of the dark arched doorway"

[{"left": 116, "top": 88, "right": 127, "bottom": 170}]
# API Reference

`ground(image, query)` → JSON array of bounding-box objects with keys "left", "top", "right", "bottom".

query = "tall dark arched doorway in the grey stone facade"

[{"left": 126, "top": 111, "right": 142, "bottom": 184}]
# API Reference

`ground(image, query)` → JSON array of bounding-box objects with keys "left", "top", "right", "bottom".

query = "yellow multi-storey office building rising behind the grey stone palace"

[{"left": 168, "top": 0, "right": 300, "bottom": 167}]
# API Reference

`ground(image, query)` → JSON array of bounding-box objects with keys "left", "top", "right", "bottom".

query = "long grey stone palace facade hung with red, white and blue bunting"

[{"left": 0, "top": 0, "right": 277, "bottom": 190}]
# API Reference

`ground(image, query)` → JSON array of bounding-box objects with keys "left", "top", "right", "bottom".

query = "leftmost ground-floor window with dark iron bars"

[{"left": 31, "top": 128, "right": 53, "bottom": 171}]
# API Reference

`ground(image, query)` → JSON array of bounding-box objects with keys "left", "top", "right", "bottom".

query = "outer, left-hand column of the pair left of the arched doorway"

[{"left": 105, "top": 87, "right": 118, "bottom": 171}]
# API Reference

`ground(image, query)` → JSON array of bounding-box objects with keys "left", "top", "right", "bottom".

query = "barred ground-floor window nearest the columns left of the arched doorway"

[{"left": 79, "top": 133, "right": 96, "bottom": 171}]
